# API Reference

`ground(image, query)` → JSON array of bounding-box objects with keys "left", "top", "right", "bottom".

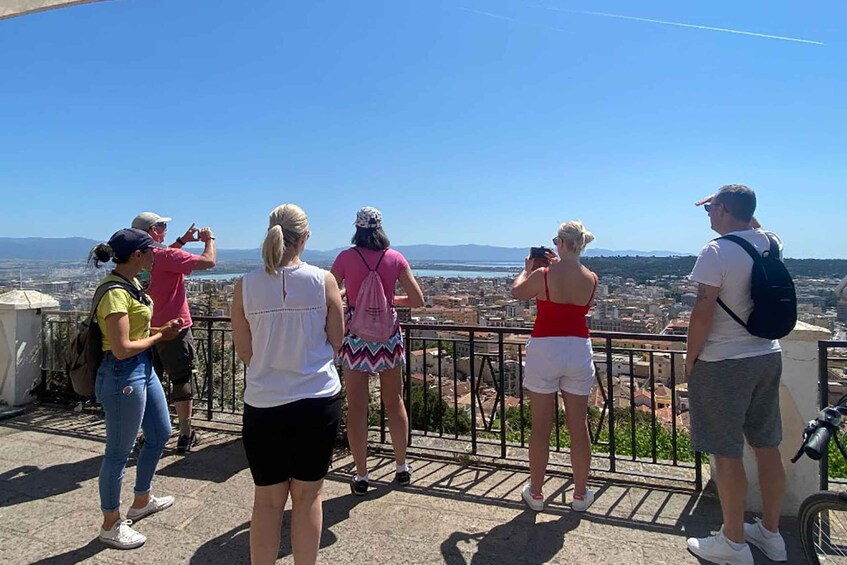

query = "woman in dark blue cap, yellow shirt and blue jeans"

[{"left": 89, "top": 228, "right": 182, "bottom": 549}]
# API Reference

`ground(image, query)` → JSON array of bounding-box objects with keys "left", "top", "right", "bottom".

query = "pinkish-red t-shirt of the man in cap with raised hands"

[{"left": 147, "top": 247, "right": 200, "bottom": 328}]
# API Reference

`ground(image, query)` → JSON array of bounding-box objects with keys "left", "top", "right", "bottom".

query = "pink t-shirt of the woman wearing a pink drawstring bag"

[{"left": 332, "top": 247, "right": 409, "bottom": 307}]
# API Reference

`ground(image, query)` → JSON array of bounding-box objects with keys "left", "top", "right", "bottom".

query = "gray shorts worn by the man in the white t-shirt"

[{"left": 688, "top": 352, "right": 782, "bottom": 458}]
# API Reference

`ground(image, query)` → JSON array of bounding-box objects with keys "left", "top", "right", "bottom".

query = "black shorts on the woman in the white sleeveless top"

[{"left": 242, "top": 394, "right": 342, "bottom": 487}]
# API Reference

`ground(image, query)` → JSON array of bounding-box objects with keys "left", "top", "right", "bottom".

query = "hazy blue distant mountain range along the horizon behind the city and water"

[{"left": 0, "top": 237, "right": 690, "bottom": 263}]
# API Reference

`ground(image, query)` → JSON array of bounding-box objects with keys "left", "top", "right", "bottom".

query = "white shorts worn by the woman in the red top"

[{"left": 523, "top": 337, "right": 595, "bottom": 396}]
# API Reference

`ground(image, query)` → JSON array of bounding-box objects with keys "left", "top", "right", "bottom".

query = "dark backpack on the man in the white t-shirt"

[{"left": 717, "top": 233, "right": 797, "bottom": 339}]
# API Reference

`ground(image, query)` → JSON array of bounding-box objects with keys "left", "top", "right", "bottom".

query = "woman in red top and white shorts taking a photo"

[{"left": 512, "top": 221, "right": 597, "bottom": 512}]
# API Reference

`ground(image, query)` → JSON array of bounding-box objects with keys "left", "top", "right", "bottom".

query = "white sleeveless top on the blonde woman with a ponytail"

[{"left": 241, "top": 263, "right": 341, "bottom": 408}]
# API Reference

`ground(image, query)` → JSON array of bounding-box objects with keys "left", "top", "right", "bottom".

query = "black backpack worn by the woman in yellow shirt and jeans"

[{"left": 61, "top": 281, "right": 141, "bottom": 396}]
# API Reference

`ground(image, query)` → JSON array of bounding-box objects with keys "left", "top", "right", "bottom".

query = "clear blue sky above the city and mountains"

[{"left": 0, "top": 0, "right": 847, "bottom": 258}]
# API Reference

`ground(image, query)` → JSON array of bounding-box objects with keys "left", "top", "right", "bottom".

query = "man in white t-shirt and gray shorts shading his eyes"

[{"left": 685, "top": 184, "right": 787, "bottom": 565}]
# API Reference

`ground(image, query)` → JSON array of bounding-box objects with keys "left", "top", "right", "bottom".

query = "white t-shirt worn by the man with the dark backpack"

[{"left": 691, "top": 229, "right": 782, "bottom": 361}]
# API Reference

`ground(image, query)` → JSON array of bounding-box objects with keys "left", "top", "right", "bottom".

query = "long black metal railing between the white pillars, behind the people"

[{"left": 39, "top": 312, "right": 702, "bottom": 490}]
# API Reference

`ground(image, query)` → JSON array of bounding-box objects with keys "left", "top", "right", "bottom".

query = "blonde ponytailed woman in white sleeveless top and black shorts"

[{"left": 232, "top": 204, "right": 344, "bottom": 564}]
